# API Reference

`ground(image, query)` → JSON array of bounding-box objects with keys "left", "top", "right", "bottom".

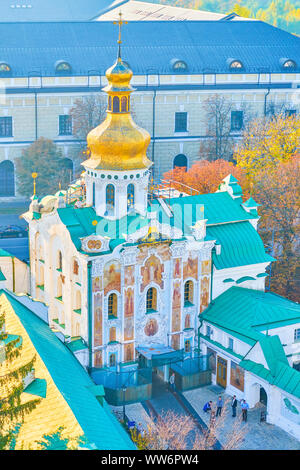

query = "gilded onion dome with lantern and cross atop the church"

[{"left": 83, "top": 15, "right": 151, "bottom": 171}]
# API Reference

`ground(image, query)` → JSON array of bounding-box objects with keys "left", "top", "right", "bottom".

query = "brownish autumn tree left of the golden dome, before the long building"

[{"left": 17, "top": 137, "right": 71, "bottom": 196}]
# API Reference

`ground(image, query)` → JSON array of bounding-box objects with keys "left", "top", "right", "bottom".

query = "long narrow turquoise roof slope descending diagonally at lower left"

[{"left": 0, "top": 290, "right": 135, "bottom": 450}]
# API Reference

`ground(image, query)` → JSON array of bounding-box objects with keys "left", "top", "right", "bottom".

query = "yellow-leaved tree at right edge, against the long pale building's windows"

[{"left": 234, "top": 114, "right": 300, "bottom": 183}]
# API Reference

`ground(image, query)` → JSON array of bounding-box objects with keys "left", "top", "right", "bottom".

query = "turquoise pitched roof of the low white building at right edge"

[{"left": 201, "top": 286, "right": 300, "bottom": 344}]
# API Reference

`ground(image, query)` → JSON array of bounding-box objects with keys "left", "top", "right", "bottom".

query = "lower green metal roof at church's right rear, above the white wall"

[{"left": 206, "top": 222, "right": 274, "bottom": 269}]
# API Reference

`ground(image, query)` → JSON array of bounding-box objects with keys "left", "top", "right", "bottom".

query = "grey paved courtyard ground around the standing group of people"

[{"left": 183, "top": 386, "right": 300, "bottom": 450}]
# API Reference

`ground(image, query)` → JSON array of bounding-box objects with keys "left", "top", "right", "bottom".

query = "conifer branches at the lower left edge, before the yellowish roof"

[{"left": 0, "top": 314, "right": 40, "bottom": 450}]
